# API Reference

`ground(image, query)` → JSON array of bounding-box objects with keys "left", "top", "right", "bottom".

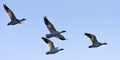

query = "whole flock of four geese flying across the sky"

[{"left": 3, "top": 4, "right": 107, "bottom": 55}]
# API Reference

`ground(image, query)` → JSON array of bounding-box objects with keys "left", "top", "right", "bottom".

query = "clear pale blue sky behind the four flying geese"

[{"left": 0, "top": 0, "right": 120, "bottom": 60}]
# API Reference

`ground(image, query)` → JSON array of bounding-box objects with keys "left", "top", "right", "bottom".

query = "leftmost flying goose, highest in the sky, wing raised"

[{"left": 3, "top": 4, "right": 26, "bottom": 25}]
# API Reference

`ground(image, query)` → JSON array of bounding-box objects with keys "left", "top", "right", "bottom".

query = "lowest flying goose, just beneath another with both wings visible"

[{"left": 41, "top": 37, "right": 64, "bottom": 55}]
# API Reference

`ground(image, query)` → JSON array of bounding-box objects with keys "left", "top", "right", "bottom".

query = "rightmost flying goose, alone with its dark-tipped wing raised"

[{"left": 85, "top": 33, "right": 107, "bottom": 48}]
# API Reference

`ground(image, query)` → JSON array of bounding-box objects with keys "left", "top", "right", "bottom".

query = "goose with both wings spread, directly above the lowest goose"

[{"left": 44, "top": 16, "right": 66, "bottom": 40}]
